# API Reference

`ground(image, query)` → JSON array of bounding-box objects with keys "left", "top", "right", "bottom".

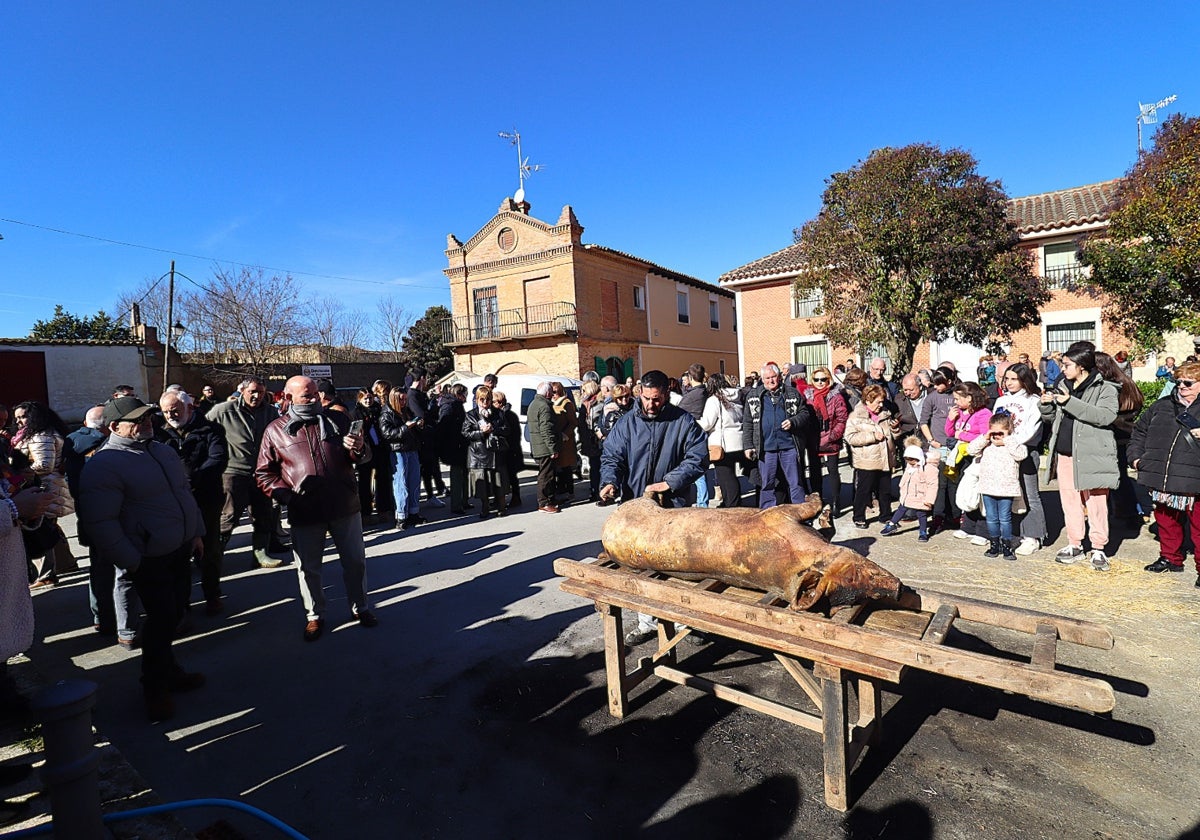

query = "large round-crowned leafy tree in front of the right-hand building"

[{"left": 794, "top": 144, "right": 1049, "bottom": 371}]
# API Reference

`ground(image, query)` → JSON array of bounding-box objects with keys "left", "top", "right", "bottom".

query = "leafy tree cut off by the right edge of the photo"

[{"left": 1080, "top": 114, "right": 1200, "bottom": 348}]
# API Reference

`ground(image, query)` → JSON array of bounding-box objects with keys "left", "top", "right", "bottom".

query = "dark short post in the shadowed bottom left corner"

[{"left": 31, "top": 679, "right": 108, "bottom": 840}]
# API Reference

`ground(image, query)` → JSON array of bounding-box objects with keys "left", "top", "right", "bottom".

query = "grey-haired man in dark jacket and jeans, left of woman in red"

[{"left": 742, "top": 362, "right": 821, "bottom": 508}]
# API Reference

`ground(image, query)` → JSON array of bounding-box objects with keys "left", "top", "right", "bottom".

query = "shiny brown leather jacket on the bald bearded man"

[{"left": 254, "top": 412, "right": 371, "bottom": 526}]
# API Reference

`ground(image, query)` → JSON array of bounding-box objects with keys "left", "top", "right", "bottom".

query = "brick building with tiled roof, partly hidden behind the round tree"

[{"left": 718, "top": 180, "right": 1166, "bottom": 378}]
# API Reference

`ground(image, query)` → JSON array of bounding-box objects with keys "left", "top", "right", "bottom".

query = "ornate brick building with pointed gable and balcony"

[{"left": 442, "top": 198, "right": 738, "bottom": 379}]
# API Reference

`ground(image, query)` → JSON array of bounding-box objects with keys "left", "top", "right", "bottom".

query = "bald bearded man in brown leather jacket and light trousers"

[{"left": 254, "top": 377, "right": 378, "bottom": 642}]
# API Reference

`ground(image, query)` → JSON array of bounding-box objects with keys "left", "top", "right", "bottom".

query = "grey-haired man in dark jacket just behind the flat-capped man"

[{"left": 155, "top": 391, "right": 229, "bottom": 616}]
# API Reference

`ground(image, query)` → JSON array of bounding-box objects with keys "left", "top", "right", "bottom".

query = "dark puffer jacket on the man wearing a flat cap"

[{"left": 79, "top": 434, "right": 204, "bottom": 571}]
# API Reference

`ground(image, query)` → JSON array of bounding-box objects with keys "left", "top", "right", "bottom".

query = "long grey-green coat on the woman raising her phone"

[{"left": 1039, "top": 372, "right": 1121, "bottom": 490}]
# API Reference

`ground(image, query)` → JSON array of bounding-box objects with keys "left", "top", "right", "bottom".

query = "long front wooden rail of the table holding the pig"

[{"left": 554, "top": 562, "right": 1116, "bottom": 713}]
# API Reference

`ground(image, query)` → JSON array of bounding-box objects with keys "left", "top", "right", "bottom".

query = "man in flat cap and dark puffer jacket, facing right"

[{"left": 78, "top": 397, "right": 204, "bottom": 721}]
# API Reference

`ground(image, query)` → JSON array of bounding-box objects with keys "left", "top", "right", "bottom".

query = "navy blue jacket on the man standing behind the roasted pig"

[{"left": 600, "top": 403, "right": 708, "bottom": 506}]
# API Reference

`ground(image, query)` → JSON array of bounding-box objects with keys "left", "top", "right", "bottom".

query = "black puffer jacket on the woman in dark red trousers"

[{"left": 1128, "top": 392, "right": 1200, "bottom": 496}]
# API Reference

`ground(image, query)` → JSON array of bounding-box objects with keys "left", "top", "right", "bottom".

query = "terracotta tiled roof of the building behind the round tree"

[{"left": 716, "top": 178, "right": 1121, "bottom": 283}]
